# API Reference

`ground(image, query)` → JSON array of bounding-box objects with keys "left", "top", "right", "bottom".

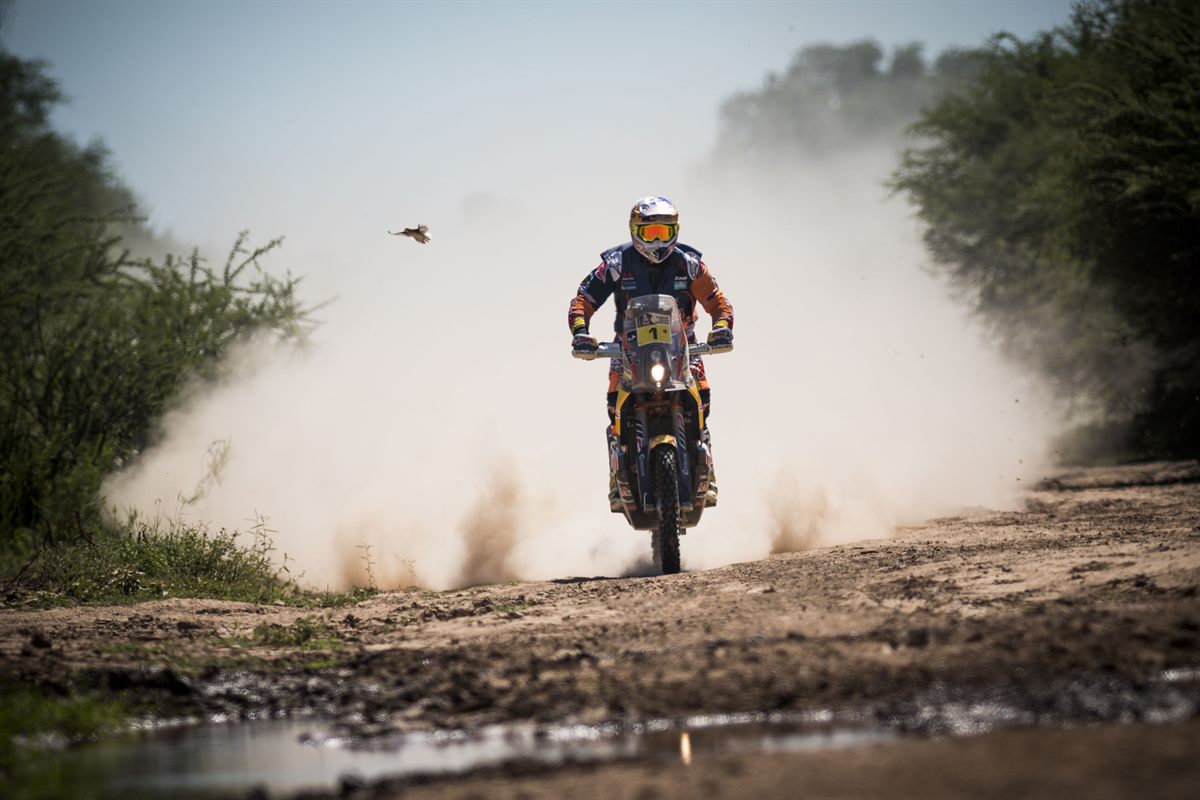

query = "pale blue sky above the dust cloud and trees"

[{"left": 0, "top": 0, "right": 1069, "bottom": 260}]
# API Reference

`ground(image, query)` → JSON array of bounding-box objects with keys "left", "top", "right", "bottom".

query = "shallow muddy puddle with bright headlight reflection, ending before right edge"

[{"left": 37, "top": 714, "right": 896, "bottom": 800}]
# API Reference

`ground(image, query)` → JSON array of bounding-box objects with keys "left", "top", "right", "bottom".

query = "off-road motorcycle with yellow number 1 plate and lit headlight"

[{"left": 572, "top": 295, "right": 733, "bottom": 575}]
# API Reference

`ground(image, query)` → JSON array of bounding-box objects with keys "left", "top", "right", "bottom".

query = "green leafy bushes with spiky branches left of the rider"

[{"left": 0, "top": 38, "right": 306, "bottom": 569}]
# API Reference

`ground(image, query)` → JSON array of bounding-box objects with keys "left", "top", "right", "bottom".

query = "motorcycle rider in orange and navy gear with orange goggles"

[{"left": 566, "top": 197, "right": 733, "bottom": 511}]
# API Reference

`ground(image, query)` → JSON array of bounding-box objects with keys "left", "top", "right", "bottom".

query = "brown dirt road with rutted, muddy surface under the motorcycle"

[{"left": 0, "top": 462, "right": 1200, "bottom": 798}]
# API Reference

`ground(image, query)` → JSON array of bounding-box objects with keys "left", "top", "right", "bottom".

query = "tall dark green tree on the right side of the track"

[{"left": 895, "top": 0, "right": 1200, "bottom": 457}]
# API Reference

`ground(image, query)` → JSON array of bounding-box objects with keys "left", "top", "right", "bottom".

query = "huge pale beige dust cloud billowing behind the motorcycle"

[{"left": 107, "top": 140, "right": 1056, "bottom": 589}]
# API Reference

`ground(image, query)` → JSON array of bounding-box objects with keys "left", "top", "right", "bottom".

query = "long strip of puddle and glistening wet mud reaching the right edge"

[{"left": 30, "top": 667, "right": 1200, "bottom": 800}]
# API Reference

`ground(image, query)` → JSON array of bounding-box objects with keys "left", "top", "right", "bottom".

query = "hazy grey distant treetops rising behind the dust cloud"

[{"left": 718, "top": 40, "right": 977, "bottom": 161}]
